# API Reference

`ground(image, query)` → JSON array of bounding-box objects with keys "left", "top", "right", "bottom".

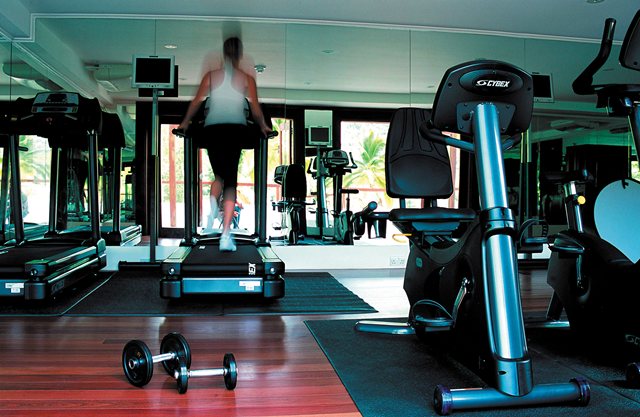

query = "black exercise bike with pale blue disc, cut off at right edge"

[{"left": 547, "top": 11, "right": 640, "bottom": 383}]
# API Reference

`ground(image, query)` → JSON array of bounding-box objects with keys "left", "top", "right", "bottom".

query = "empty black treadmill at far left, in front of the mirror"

[{"left": 0, "top": 92, "right": 107, "bottom": 300}]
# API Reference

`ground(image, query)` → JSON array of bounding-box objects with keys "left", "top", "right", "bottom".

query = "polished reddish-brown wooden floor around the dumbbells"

[{"left": 0, "top": 270, "right": 550, "bottom": 417}]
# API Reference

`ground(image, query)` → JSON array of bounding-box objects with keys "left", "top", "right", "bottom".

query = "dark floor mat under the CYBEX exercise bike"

[{"left": 306, "top": 320, "right": 640, "bottom": 417}]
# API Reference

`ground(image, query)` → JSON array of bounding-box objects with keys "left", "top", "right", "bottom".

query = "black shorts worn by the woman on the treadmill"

[{"left": 200, "top": 124, "right": 249, "bottom": 188}]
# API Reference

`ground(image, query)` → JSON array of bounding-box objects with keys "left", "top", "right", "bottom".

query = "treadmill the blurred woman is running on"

[{"left": 160, "top": 117, "right": 285, "bottom": 299}]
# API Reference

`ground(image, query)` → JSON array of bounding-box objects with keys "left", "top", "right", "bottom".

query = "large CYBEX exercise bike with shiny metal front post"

[{"left": 357, "top": 60, "right": 590, "bottom": 414}]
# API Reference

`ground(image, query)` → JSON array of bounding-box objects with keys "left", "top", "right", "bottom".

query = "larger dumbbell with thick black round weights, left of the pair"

[{"left": 122, "top": 332, "right": 191, "bottom": 387}]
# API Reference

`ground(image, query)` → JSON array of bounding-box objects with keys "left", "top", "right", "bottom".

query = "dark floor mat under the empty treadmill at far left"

[{"left": 0, "top": 273, "right": 113, "bottom": 317}]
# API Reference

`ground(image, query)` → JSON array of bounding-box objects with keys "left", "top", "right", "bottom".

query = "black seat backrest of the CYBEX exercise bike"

[{"left": 385, "top": 107, "right": 453, "bottom": 200}]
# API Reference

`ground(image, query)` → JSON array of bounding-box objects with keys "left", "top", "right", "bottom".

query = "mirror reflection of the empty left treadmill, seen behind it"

[{"left": 52, "top": 112, "right": 142, "bottom": 246}]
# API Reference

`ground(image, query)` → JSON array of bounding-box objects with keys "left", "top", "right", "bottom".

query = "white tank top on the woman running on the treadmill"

[{"left": 204, "top": 63, "right": 249, "bottom": 126}]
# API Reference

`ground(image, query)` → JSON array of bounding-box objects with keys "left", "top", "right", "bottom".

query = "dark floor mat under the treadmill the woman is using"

[{"left": 67, "top": 271, "right": 375, "bottom": 316}]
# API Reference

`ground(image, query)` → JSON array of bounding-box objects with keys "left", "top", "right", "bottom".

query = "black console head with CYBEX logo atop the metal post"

[{"left": 431, "top": 60, "right": 533, "bottom": 136}]
